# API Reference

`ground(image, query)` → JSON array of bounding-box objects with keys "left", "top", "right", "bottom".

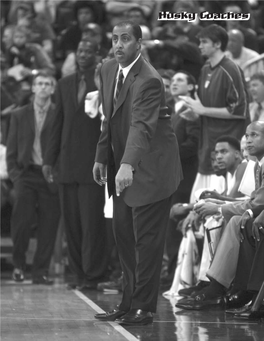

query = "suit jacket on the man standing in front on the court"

[{"left": 96, "top": 57, "right": 182, "bottom": 207}]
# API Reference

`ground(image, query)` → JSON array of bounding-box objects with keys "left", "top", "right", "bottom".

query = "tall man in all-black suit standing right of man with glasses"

[{"left": 43, "top": 41, "right": 106, "bottom": 290}]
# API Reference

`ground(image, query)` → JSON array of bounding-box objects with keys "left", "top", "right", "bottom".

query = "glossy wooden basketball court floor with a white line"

[{"left": 1, "top": 273, "right": 264, "bottom": 341}]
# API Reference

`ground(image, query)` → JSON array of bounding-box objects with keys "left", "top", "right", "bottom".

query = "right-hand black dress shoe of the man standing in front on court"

[{"left": 116, "top": 309, "right": 153, "bottom": 326}]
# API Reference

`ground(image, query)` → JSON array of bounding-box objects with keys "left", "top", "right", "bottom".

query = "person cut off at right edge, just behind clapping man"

[{"left": 249, "top": 71, "right": 264, "bottom": 122}]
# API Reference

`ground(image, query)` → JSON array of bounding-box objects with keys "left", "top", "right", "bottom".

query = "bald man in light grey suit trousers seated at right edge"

[{"left": 177, "top": 121, "right": 264, "bottom": 310}]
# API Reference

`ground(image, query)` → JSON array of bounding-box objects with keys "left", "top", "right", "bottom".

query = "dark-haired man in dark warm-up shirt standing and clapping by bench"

[{"left": 178, "top": 24, "right": 248, "bottom": 202}]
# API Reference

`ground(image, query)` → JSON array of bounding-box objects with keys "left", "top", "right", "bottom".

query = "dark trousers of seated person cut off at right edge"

[{"left": 234, "top": 219, "right": 264, "bottom": 291}]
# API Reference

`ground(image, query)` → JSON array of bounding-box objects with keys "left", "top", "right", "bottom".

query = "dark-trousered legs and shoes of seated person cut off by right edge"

[{"left": 226, "top": 204, "right": 264, "bottom": 318}]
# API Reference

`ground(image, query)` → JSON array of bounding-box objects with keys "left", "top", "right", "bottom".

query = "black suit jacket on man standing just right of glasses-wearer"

[{"left": 44, "top": 68, "right": 101, "bottom": 184}]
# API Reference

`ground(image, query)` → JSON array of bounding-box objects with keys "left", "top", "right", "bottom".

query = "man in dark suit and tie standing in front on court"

[{"left": 93, "top": 21, "right": 181, "bottom": 325}]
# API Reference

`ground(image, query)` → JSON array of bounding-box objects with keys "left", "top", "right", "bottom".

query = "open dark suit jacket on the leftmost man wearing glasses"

[{"left": 6, "top": 103, "right": 54, "bottom": 182}]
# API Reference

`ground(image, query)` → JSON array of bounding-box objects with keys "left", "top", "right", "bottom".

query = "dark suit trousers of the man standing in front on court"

[{"left": 113, "top": 196, "right": 171, "bottom": 312}]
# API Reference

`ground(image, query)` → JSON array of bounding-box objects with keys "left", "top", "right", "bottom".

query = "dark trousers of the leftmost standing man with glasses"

[{"left": 11, "top": 167, "right": 60, "bottom": 276}]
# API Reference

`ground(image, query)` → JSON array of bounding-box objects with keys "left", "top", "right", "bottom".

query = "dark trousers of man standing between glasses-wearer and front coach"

[{"left": 60, "top": 183, "right": 107, "bottom": 281}]
